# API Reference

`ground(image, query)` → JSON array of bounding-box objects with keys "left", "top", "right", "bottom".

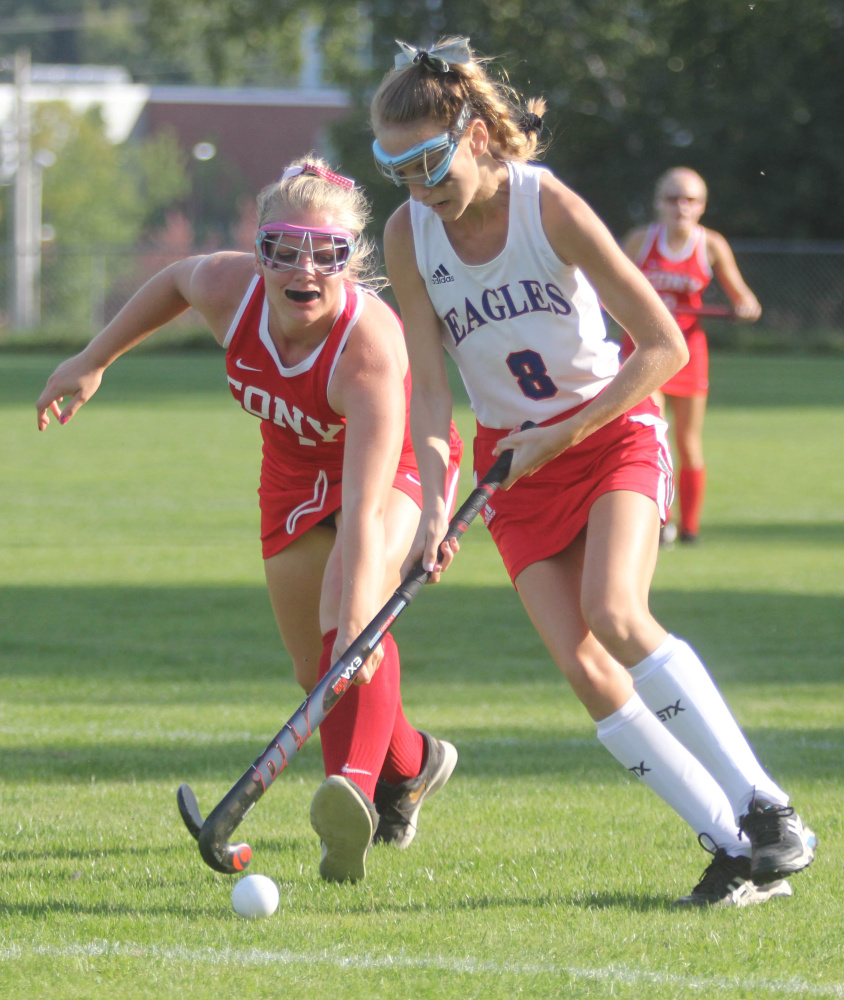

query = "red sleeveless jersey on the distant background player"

[{"left": 636, "top": 224, "right": 712, "bottom": 335}]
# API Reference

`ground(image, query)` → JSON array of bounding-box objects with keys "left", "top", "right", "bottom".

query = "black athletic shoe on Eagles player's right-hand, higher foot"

[{"left": 739, "top": 797, "right": 818, "bottom": 883}]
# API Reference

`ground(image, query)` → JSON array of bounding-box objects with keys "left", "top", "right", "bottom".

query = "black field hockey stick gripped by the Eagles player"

[{"left": 176, "top": 421, "right": 535, "bottom": 875}]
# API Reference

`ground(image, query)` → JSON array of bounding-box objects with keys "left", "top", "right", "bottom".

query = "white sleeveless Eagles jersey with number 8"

[{"left": 410, "top": 161, "right": 619, "bottom": 430}]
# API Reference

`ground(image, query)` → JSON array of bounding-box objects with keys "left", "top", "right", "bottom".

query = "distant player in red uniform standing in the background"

[{"left": 622, "top": 167, "right": 762, "bottom": 542}]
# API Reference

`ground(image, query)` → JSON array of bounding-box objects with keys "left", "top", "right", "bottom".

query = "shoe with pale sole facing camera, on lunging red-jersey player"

[{"left": 311, "top": 774, "right": 378, "bottom": 882}]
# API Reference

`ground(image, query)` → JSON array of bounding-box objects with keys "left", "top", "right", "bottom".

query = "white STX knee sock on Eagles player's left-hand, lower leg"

[{"left": 597, "top": 694, "right": 750, "bottom": 855}]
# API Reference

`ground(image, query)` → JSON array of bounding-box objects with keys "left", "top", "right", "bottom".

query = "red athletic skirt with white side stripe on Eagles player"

[{"left": 474, "top": 397, "right": 673, "bottom": 583}]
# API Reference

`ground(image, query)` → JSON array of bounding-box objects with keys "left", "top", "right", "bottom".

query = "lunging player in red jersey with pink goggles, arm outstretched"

[{"left": 36, "top": 157, "right": 462, "bottom": 881}]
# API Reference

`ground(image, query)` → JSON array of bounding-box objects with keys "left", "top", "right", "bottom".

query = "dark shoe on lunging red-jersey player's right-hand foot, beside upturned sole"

[{"left": 373, "top": 733, "right": 457, "bottom": 848}]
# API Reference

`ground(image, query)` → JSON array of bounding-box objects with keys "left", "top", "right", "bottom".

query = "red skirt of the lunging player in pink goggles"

[{"left": 259, "top": 423, "right": 463, "bottom": 559}]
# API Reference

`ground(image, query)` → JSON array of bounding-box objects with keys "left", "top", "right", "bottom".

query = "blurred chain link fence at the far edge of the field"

[{"left": 0, "top": 240, "right": 844, "bottom": 352}]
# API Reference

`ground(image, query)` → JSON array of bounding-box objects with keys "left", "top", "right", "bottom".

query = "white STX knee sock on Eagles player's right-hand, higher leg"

[{"left": 630, "top": 635, "right": 788, "bottom": 819}]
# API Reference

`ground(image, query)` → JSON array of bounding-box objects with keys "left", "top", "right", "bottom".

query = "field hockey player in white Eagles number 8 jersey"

[{"left": 371, "top": 38, "right": 815, "bottom": 906}]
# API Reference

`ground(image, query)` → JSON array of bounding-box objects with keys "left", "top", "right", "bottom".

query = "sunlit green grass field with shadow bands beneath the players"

[{"left": 0, "top": 352, "right": 844, "bottom": 1000}]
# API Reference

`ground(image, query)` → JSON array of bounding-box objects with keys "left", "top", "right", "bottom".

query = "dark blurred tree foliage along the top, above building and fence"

[{"left": 6, "top": 0, "right": 844, "bottom": 239}]
